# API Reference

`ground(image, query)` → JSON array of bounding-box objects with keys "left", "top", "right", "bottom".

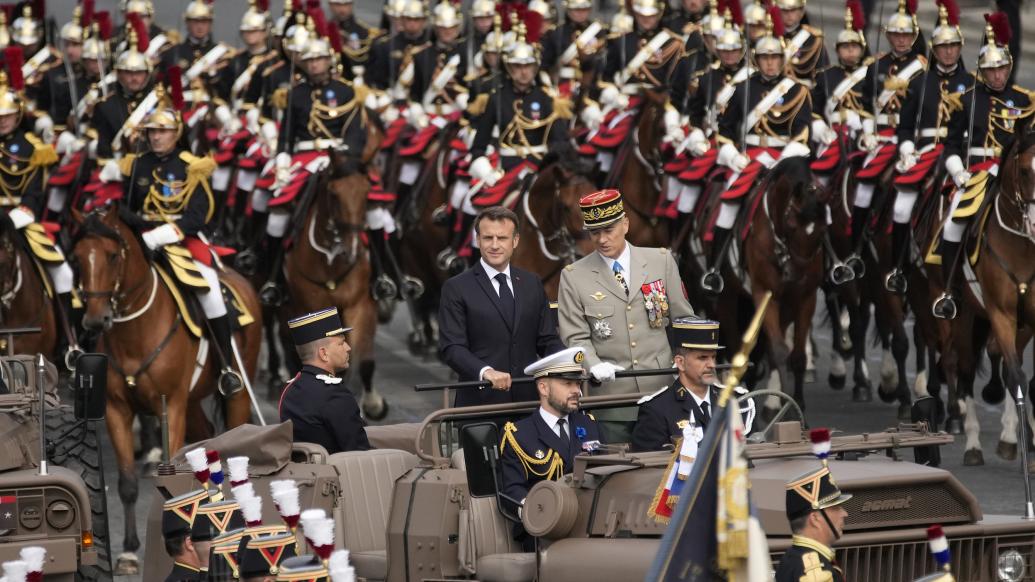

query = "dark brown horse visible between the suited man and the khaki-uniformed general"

[{"left": 511, "top": 148, "right": 596, "bottom": 299}]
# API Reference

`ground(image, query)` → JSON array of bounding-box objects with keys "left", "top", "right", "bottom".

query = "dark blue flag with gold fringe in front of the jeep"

[{"left": 647, "top": 391, "right": 770, "bottom": 582}]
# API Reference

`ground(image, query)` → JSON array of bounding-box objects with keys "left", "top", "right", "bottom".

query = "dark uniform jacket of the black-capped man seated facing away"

[{"left": 279, "top": 366, "right": 371, "bottom": 455}]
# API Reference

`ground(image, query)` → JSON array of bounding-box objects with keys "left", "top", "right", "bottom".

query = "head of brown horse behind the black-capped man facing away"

[{"left": 316, "top": 153, "right": 371, "bottom": 264}]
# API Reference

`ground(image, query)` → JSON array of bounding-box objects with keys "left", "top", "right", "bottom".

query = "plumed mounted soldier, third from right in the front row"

[{"left": 852, "top": 0, "right": 927, "bottom": 254}]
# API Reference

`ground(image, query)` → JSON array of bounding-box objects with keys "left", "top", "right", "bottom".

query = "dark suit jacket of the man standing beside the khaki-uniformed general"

[{"left": 439, "top": 261, "right": 564, "bottom": 406}]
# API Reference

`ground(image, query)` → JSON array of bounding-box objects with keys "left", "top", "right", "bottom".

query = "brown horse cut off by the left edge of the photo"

[{"left": 0, "top": 213, "right": 58, "bottom": 355}]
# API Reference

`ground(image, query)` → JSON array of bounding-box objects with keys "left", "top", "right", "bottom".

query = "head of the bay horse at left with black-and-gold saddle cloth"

[{"left": 72, "top": 203, "right": 147, "bottom": 331}]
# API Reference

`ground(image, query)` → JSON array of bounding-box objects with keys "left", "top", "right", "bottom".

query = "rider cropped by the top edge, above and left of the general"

[{"left": 539, "top": 0, "right": 608, "bottom": 95}]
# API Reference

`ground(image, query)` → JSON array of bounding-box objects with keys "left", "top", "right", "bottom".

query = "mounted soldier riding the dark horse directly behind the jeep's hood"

[{"left": 701, "top": 8, "right": 812, "bottom": 294}]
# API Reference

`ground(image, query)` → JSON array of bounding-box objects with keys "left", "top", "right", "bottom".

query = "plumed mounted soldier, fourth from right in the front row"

[{"left": 810, "top": 0, "right": 874, "bottom": 191}]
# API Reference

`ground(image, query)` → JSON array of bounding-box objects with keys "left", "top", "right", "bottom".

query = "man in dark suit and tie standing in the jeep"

[{"left": 439, "top": 206, "right": 564, "bottom": 406}]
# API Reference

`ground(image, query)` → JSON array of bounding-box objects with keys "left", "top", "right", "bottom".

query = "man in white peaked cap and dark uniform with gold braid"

[{"left": 500, "top": 348, "right": 600, "bottom": 551}]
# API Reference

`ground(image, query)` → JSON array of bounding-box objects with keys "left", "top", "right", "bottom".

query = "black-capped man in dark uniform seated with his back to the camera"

[{"left": 278, "top": 308, "right": 371, "bottom": 455}]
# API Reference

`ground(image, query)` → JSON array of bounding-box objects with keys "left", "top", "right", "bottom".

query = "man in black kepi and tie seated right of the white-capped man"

[{"left": 632, "top": 318, "right": 755, "bottom": 450}]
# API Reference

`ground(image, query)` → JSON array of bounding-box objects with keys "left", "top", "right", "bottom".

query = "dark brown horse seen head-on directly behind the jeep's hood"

[{"left": 738, "top": 157, "right": 827, "bottom": 410}]
